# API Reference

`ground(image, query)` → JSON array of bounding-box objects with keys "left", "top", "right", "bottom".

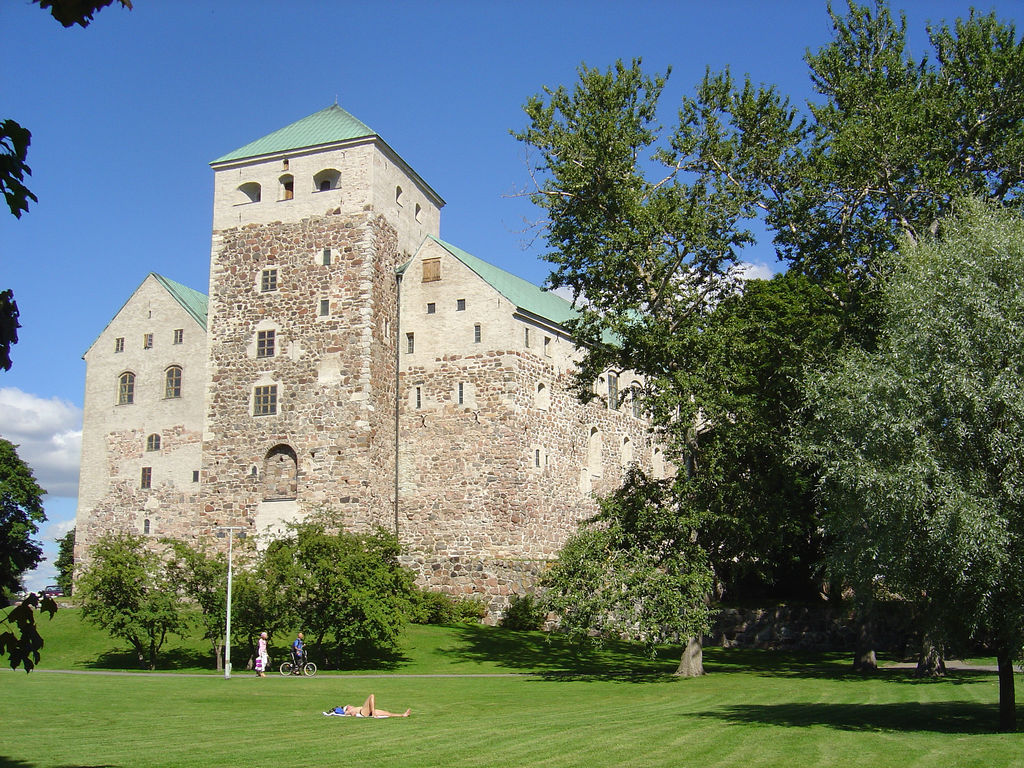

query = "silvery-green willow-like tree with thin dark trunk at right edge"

[{"left": 796, "top": 201, "right": 1024, "bottom": 730}]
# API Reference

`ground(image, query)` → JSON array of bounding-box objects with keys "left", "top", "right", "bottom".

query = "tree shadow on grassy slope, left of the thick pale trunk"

[{"left": 441, "top": 625, "right": 681, "bottom": 682}]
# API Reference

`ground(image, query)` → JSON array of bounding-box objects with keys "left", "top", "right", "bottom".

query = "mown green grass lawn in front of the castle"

[{"left": 0, "top": 611, "right": 1024, "bottom": 768}]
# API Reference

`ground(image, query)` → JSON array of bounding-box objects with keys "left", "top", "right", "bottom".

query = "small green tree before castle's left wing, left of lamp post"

[{"left": 78, "top": 534, "right": 187, "bottom": 670}]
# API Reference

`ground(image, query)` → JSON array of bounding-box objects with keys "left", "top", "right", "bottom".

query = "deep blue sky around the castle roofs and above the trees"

[{"left": 0, "top": 0, "right": 1024, "bottom": 588}]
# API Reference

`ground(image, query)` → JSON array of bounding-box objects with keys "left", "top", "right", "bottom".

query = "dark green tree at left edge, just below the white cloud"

[{"left": 0, "top": 438, "right": 46, "bottom": 595}]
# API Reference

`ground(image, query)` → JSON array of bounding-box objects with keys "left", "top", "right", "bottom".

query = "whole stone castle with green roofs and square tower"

[{"left": 76, "top": 104, "right": 665, "bottom": 613}]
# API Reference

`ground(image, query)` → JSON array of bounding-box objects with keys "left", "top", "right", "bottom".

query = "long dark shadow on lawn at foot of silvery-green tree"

[{"left": 696, "top": 701, "right": 999, "bottom": 734}]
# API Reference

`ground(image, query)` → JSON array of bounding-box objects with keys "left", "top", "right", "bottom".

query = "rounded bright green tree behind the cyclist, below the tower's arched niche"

[{"left": 261, "top": 513, "right": 413, "bottom": 663}]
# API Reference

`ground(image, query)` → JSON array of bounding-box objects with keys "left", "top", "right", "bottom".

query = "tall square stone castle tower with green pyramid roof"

[{"left": 200, "top": 104, "right": 443, "bottom": 532}]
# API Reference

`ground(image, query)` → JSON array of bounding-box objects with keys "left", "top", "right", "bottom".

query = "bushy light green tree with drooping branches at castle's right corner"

[{"left": 542, "top": 467, "right": 712, "bottom": 677}]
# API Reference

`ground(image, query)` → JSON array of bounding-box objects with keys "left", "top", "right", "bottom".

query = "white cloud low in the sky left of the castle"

[{"left": 0, "top": 387, "right": 82, "bottom": 498}]
